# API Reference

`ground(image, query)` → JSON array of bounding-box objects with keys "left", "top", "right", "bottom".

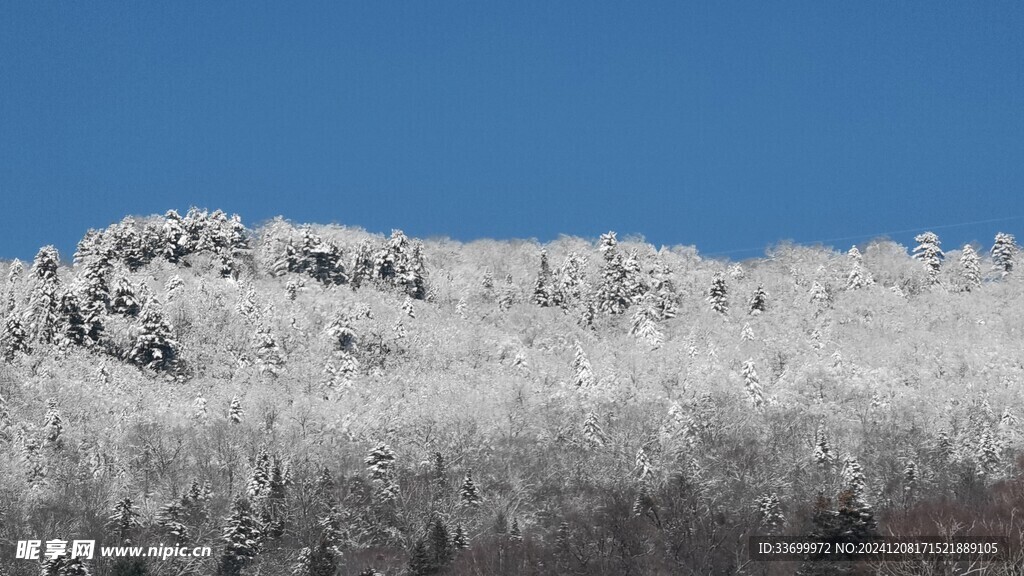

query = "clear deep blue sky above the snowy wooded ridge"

[{"left": 0, "top": 0, "right": 1024, "bottom": 257}]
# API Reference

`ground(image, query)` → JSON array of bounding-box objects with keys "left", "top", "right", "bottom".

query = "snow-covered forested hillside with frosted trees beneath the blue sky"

[{"left": 0, "top": 208, "right": 1024, "bottom": 576}]
